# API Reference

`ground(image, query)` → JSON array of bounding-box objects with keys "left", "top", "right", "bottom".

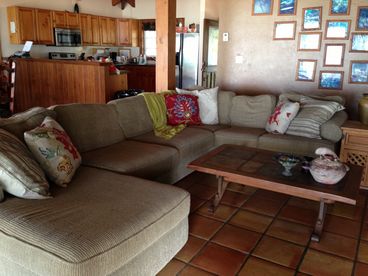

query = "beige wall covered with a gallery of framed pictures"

[{"left": 218, "top": 0, "right": 368, "bottom": 118}]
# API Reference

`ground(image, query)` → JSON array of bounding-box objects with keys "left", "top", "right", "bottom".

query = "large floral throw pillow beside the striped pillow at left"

[{"left": 24, "top": 117, "right": 82, "bottom": 187}]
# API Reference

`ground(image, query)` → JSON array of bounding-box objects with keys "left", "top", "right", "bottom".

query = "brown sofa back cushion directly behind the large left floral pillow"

[{"left": 53, "top": 104, "right": 125, "bottom": 152}]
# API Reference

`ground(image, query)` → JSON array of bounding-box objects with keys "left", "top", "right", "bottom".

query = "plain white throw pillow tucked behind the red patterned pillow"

[{"left": 176, "top": 87, "right": 219, "bottom": 125}]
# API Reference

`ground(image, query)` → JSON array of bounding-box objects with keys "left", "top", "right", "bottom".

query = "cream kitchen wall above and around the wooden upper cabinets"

[{"left": 0, "top": 0, "right": 200, "bottom": 57}]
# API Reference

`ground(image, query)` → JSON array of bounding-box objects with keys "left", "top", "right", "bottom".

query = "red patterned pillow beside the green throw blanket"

[{"left": 165, "top": 95, "right": 201, "bottom": 126}]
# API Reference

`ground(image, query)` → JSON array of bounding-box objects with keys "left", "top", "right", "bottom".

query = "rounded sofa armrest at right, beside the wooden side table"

[{"left": 321, "top": 110, "right": 348, "bottom": 142}]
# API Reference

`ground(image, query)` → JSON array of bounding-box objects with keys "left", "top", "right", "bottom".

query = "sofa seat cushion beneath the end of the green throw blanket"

[{"left": 132, "top": 127, "right": 214, "bottom": 162}]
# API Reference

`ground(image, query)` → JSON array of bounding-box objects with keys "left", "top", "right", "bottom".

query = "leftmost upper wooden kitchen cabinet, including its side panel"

[{"left": 7, "top": 7, "right": 37, "bottom": 44}]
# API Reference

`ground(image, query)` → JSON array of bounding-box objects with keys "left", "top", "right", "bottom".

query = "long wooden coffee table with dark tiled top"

[{"left": 188, "top": 145, "right": 362, "bottom": 242}]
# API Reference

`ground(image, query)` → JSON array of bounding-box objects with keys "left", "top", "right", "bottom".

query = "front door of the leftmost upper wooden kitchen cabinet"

[{"left": 18, "top": 7, "right": 37, "bottom": 43}]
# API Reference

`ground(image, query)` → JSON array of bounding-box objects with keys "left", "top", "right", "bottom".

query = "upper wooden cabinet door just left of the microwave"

[{"left": 36, "top": 9, "right": 54, "bottom": 45}]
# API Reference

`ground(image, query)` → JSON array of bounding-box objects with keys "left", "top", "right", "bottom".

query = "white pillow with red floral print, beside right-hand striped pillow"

[{"left": 266, "top": 100, "right": 300, "bottom": 134}]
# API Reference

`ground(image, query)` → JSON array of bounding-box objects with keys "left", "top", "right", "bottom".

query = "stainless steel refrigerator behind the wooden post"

[{"left": 176, "top": 33, "right": 199, "bottom": 88}]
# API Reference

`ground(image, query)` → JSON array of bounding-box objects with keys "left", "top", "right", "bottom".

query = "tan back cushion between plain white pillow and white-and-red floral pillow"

[{"left": 230, "top": 95, "right": 276, "bottom": 128}]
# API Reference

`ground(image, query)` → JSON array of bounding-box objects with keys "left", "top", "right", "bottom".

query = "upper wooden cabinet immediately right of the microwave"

[{"left": 79, "top": 14, "right": 100, "bottom": 45}]
